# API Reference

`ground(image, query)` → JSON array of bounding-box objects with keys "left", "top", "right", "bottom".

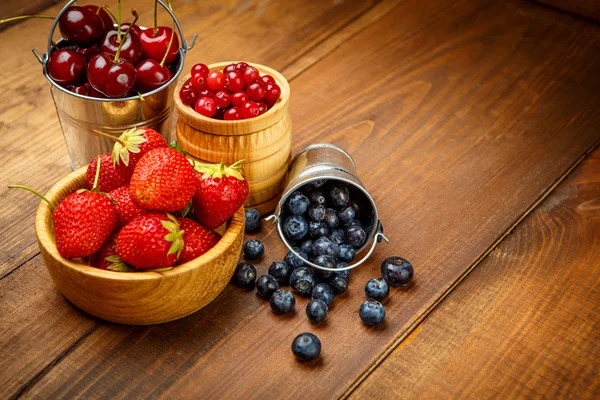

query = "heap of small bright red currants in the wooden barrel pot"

[{"left": 179, "top": 62, "right": 281, "bottom": 121}]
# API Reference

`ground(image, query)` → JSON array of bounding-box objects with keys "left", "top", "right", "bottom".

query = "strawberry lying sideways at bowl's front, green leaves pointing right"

[{"left": 117, "top": 213, "right": 184, "bottom": 269}]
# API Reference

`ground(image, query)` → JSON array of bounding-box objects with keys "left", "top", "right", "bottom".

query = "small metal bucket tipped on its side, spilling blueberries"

[{"left": 266, "top": 144, "right": 388, "bottom": 271}]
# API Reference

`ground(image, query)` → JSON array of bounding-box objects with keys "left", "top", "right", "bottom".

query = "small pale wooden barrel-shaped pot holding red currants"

[{"left": 175, "top": 62, "right": 292, "bottom": 214}]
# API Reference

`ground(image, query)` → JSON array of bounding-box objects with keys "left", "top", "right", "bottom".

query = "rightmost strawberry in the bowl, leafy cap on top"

[{"left": 193, "top": 161, "right": 249, "bottom": 229}]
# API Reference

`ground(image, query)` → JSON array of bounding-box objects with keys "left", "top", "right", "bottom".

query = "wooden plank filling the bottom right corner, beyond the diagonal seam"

[{"left": 352, "top": 149, "right": 600, "bottom": 399}]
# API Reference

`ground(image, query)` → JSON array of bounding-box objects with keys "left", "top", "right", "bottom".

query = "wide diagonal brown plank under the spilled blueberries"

[{"left": 12, "top": 0, "right": 600, "bottom": 398}]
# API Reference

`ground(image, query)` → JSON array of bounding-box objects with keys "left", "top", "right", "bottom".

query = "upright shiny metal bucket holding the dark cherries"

[{"left": 32, "top": 0, "right": 197, "bottom": 169}]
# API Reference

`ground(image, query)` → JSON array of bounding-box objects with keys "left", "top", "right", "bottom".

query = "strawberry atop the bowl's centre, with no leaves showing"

[{"left": 129, "top": 147, "right": 198, "bottom": 211}]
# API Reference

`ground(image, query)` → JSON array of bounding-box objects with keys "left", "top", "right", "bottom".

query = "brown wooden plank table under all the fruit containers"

[{"left": 0, "top": 0, "right": 600, "bottom": 399}]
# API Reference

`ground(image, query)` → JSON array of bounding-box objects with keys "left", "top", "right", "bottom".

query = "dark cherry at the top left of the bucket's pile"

[{"left": 58, "top": 6, "right": 104, "bottom": 46}]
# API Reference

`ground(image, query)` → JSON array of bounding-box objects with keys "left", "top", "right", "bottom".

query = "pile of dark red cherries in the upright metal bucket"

[{"left": 47, "top": 4, "right": 179, "bottom": 98}]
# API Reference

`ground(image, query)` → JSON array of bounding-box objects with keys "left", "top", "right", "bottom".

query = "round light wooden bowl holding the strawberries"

[{"left": 35, "top": 167, "right": 244, "bottom": 325}]
